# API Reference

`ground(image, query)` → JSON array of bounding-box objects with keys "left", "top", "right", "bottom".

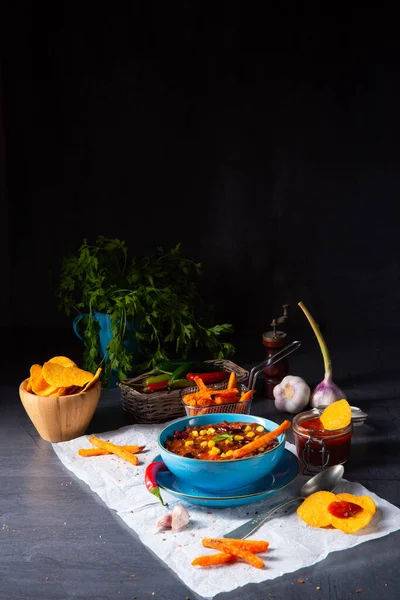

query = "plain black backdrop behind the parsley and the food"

[{"left": 0, "top": 1, "right": 400, "bottom": 380}]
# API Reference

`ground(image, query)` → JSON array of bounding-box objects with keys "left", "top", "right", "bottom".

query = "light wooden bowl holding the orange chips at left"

[{"left": 19, "top": 379, "right": 101, "bottom": 442}]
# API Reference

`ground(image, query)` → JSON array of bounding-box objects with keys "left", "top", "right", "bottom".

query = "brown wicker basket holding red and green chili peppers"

[{"left": 118, "top": 359, "right": 249, "bottom": 423}]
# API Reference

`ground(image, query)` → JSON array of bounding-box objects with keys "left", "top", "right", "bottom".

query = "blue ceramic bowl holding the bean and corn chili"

[{"left": 158, "top": 413, "right": 286, "bottom": 492}]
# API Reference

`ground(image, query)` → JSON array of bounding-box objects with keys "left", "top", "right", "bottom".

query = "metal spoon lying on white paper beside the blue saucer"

[{"left": 223, "top": 465, "right": 344, "bottom": 540}]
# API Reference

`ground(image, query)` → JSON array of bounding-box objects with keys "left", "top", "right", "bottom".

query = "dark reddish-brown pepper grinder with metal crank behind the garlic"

[{"left": 262, "top": 304, "right": 289, "bottom": 400}]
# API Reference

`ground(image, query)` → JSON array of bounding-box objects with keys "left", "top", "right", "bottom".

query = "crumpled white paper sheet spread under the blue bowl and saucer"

[{"left": 52, "top": 424, "right": 400, "bottom": 598}]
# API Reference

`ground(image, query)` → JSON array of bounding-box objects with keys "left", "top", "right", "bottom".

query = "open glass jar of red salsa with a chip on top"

[{"left": 292, "top": 408, "right": 353, "bottom": 470}]
